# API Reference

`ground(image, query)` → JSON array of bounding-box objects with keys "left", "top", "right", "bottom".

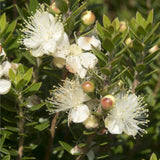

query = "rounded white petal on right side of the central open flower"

[{"left": 80, "top": 52, "right": 98, "bottom": 69}]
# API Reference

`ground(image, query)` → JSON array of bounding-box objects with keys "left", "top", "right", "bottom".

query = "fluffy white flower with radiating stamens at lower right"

[{"left": 104, "top": 92, "right": 148, "bottom": 136}]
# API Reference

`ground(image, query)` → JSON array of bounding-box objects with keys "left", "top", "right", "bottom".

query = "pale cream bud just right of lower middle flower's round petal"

[{"left": 83, "top": 115, "right": 98, "bottom": 129}]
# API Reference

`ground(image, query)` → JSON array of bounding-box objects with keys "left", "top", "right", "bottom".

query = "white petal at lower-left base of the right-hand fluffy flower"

[{"left": 105, "top": 117, "right": 124, "bottom": 134}]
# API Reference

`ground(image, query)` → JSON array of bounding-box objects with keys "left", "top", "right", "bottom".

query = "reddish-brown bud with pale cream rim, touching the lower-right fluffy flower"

[{"left": 101, "top": 95, "right": 115, "bottom": 110}]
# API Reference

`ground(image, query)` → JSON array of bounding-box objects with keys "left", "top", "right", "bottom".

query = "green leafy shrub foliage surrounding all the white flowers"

[{"left": 0, "top": 0, "right": 160, "bottom": 160}]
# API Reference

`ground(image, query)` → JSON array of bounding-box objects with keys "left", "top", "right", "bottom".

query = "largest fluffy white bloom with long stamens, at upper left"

[{"left": 22, "top": 5, "right": 68, "bottom": 57}]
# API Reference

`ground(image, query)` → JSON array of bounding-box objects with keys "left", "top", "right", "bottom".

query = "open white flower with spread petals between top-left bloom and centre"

[{"left": 66, "top": 44, "right": 98, "bottom": 78}]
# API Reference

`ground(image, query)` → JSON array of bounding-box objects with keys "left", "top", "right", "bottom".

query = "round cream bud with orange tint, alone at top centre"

[{"left": 81, "top": 11, "right": 96, "bottom": 26}]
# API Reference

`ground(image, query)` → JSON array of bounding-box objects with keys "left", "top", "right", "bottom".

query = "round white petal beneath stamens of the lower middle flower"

[{"left": 69, "top": 104, "right": 90, "bottom": 123}]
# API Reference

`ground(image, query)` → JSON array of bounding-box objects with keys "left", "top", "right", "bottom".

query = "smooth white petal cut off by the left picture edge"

[{"left": 0, "top": 79, "right": 11, "bottom": 94}]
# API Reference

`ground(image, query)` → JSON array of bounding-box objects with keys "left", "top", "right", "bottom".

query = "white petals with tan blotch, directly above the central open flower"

[{"left": 77, "top": 36, "right": 101, "bottom": 51}]
